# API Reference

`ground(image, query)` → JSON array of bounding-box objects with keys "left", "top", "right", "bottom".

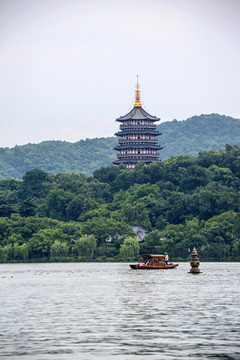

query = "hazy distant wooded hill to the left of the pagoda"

[{"left": 0, "top": 137, "right": 116, "bottom": 179}]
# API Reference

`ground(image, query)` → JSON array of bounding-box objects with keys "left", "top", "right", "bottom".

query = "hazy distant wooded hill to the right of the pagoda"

[{"left": 158, "top": 114, "right": 240, "bottom": 159}]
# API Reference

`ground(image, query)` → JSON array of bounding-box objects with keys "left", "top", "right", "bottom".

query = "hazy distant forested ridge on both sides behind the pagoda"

[{"left": 0, "top": 114, "right": 240, "bottom": 179}]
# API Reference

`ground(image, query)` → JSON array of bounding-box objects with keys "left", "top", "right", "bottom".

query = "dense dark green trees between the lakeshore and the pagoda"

[{"left": 0, "top": 145, "right": 240, "bottom": 262}]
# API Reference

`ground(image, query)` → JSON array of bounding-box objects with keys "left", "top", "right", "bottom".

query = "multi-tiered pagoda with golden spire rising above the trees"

[{"left": 113, "top": 75, "right": 163, "bottom": 169}]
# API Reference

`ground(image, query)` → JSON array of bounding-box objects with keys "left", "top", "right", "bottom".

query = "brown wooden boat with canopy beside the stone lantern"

[{"left": 130, "top": 254, "right": 178, "bottom": 270}]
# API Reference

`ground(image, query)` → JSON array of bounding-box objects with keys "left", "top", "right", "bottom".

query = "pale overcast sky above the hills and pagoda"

[{"left": 0, "top": 0, "right": 240, "bottom": 147}]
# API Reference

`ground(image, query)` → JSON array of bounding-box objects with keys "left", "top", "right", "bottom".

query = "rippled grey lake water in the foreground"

[{"left": 0, "top": 263, "right": 240, "bottom": 360}]
